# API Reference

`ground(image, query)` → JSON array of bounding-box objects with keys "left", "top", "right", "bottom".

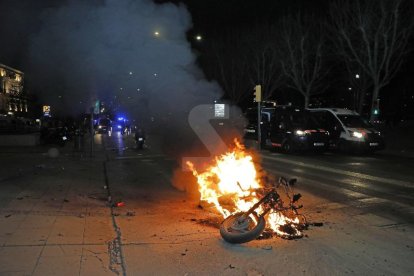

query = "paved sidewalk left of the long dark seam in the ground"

[{"left": 0, "top": 139, "right": 115, "bottom": 275}]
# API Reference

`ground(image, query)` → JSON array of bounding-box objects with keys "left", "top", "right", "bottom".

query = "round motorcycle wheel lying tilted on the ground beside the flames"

[{"left": 220, "top": 212, "right": 266, "bottom": 243}]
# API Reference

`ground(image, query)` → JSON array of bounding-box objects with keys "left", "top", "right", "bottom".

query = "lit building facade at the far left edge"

[{"left": 0, "top": 63, "right": 28, "bottom": 117}]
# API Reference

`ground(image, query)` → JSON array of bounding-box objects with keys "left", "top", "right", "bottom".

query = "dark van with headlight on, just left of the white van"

[{"left": 262, "top": 106, "right": 329, "bottom": 153}]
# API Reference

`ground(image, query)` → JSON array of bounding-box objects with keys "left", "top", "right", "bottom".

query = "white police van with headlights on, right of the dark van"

[{"left": 309, "top": 108, "right": 385, "bottom": 152}]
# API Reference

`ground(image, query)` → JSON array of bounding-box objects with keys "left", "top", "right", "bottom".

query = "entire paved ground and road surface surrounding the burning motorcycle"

[{"left": 0, "top": 135, "right": 414, "bottom": 275}]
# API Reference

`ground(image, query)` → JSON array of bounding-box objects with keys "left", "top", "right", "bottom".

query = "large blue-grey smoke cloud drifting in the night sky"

[{"left": 30, "top": 0, "right": 221, "bottom": 121}]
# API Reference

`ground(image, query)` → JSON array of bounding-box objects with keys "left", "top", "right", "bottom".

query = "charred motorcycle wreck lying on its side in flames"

[{"left": 220, "top": 177, "right": 307, "bottom": 243}]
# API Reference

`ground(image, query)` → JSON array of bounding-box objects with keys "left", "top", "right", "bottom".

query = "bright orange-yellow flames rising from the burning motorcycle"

[{"left": 187, "top": 140, "right": 301, "bottom": 237}]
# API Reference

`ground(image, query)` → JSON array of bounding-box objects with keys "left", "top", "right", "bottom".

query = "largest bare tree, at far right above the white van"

[{"left": 330, "top": 0, "right": 414, "bottom": 120}]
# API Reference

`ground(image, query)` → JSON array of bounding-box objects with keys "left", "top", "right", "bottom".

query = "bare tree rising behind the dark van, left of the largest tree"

[{"left": 279, "top": 14, "right": 329, "bottom": 108}]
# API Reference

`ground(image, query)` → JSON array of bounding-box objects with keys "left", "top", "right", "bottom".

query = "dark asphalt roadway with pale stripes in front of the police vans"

[{"left": 262, "top": 152, "right": 414, "bottom": 224}]
